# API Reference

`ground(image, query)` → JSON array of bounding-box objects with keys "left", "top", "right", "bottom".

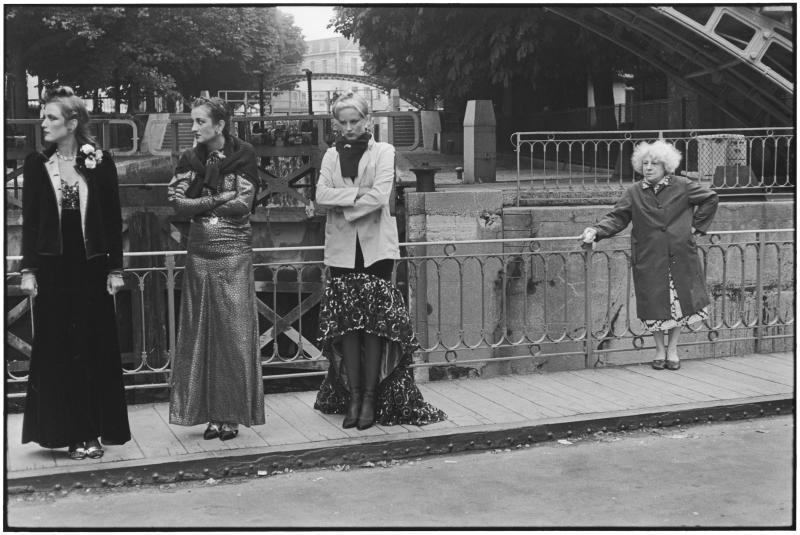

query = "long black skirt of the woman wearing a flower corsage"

[{"left": 22, "top": 210, "right": 131, "bottom": 448}]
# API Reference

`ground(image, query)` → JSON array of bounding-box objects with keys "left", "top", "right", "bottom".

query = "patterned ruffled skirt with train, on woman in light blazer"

[{"left": 314, "top": 273, "right": 447, "bottom": 425}]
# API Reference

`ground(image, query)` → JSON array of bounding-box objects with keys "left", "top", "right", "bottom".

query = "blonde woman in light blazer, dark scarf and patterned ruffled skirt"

[{"left": 314, "top": 93, "right": 445, "bottom": 429}]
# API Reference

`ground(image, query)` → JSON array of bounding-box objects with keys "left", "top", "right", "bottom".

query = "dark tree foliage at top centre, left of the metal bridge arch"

[{"left": 331, "top": 5, "right": 648, "bottom": 117}]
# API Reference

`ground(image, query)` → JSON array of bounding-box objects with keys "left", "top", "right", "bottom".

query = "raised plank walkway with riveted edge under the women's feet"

[{"left": 6, "top": 353, "right": 795, "bottom": 491}]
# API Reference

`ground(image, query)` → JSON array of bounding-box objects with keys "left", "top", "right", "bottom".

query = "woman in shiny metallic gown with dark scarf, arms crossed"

[{"left": 169, "top": 98, "right": 264, "bottom": 440}]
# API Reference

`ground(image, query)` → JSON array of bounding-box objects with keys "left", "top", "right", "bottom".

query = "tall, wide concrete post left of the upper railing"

[{"left": 464, "top": 100, "right": 497, "bottom": 184}]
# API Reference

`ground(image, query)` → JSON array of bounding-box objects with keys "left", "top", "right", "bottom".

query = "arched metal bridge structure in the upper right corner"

[{"left": 546, "top": 4, "right": 794, "bottom": 126}]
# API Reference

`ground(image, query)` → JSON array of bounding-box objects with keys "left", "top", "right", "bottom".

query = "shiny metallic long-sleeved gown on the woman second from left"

[{"left": 169, "top": 163, "right": 264, "bottom": 426}]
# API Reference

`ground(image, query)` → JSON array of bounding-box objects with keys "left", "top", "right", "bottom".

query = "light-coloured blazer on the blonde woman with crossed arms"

[{"left": 316, "top": 139, "right": 400, "bottom": 269}]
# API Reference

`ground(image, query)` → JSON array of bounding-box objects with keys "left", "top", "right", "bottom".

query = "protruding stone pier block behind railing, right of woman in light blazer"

[{"left": 406, "top": 189, "right": 503, "bottom": 381}]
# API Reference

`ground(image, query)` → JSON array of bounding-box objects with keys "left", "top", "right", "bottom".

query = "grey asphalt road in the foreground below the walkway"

[{"left": 6, "top": 416, "right": 794, "bottom": 530}]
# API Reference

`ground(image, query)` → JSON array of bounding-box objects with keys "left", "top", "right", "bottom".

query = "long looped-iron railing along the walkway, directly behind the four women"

[{"left": 6, "top": 229, "right": 795, "bottom": 397}]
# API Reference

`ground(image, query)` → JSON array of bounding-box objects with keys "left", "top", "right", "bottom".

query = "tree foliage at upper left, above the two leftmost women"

[{"left": 5, "top": 5, "right": 305, "bottom": 112}]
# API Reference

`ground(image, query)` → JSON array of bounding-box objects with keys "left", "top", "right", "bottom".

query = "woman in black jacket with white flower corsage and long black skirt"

[{"left": 20, "top": 87, "right": 131, "bottom": 460}]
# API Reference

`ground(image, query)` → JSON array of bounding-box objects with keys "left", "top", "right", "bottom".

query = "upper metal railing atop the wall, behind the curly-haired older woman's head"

[{"left": 511, "top": 128, "right": 796, "bottom": 205}]
